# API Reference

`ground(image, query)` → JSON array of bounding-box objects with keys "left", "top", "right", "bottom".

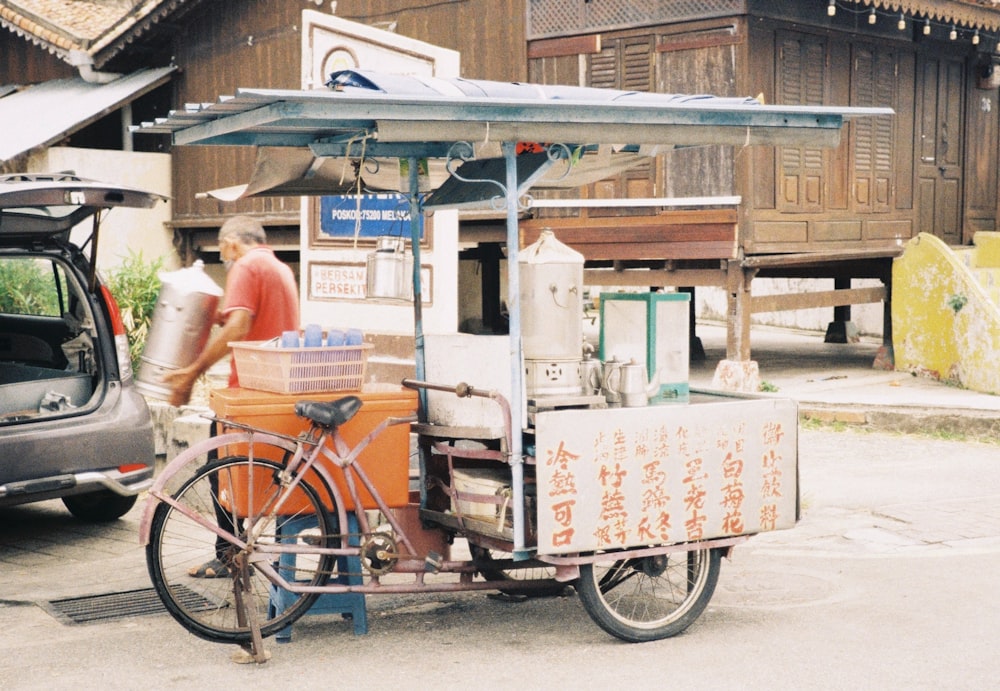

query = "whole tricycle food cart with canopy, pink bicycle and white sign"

[{"left": 135, "top": 71, "right": 885, "bottom": 660}]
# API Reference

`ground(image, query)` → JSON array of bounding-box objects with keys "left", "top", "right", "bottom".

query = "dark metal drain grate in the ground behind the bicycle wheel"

[{"left": 41, "top": 586, "right": 218, "bottom": 624}]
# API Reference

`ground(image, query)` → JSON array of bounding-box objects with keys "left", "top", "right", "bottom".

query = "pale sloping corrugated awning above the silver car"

[{"left": 0, "top": 67, "right": 177, "bottom": 162}]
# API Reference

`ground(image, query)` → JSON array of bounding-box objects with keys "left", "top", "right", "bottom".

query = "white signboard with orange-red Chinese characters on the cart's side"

[{"left": 535, "top": 395, "right": 798, "bottom": 554}]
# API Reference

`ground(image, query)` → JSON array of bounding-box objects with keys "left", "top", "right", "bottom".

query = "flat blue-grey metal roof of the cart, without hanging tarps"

[{"left": 140, "top": 72, "right": 892, "bottom": 155}]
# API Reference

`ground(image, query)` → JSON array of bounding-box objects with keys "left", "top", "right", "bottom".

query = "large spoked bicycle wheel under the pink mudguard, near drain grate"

[{"left": 146, "top": 457, "right": 340, "bottom": 643}]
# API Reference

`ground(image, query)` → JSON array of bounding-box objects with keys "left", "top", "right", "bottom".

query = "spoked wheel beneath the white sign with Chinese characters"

[{"left": 577, "top": 549, "right": 722, "bottom": 643}]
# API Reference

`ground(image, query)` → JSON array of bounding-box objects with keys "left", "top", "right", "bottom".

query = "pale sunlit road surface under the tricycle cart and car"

[{"left": 0, "top": 430, "right": 1000, "bottom": 689}]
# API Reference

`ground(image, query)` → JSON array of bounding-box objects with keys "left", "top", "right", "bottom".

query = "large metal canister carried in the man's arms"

[{"left": 136, "top": 259, "right": 222, "bottom": 399}]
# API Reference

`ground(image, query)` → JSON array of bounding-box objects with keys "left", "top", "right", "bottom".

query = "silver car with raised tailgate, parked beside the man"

[{"left": 0, "top": 174, "right": 163, "bottom": 521}]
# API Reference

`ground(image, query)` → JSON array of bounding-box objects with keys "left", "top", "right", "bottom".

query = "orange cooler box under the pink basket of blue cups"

[{"left": 209, "top": 388, "right": 417, "bottom": 513}]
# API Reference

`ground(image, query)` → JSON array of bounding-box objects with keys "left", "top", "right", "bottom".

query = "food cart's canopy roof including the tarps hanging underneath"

[{"left": 136, "top": 70, "right": 892, "bottom": 208}]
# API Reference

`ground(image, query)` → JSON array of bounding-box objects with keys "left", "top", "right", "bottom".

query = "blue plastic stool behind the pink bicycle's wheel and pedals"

[{"left": 269, "top": 513, "right": 368, "bottom": 643}]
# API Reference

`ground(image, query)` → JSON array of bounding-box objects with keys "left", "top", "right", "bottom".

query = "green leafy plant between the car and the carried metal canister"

[{"left": 108, "top": 251, "right": 163, "bottom": 368}]
